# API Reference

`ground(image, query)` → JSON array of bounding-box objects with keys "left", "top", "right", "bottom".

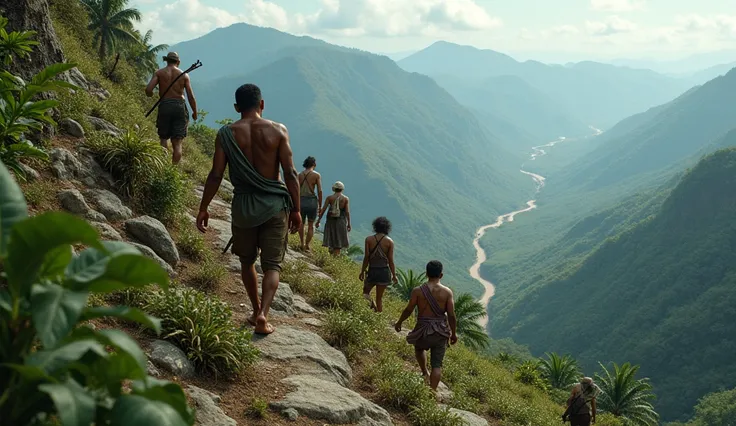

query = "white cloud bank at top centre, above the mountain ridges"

[{"left": 299, "top": 0, "right": 502, "bottom": 37}]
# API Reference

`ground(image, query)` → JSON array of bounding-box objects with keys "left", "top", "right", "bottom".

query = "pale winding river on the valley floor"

[{"left": 468, "top": 126, "right": 603, "bottom": 328}]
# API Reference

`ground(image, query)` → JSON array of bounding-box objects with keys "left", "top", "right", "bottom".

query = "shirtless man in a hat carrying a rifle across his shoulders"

[{"left": 146, "top": 52, "right": 197, "bottom": 164}]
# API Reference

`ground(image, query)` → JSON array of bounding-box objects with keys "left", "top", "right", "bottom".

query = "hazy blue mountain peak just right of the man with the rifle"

[{"left": 171, "top": 23, "right": 338, "bottom": 82}]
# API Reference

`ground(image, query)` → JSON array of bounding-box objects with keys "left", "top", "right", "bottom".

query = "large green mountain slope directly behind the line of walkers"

[{"left": 193, "top": 48, "right": 533, "bottom": 286}]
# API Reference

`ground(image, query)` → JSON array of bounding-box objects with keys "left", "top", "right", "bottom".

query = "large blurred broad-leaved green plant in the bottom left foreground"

[{"left": 0, "top": 161, "right": 194, "bottom": 426}]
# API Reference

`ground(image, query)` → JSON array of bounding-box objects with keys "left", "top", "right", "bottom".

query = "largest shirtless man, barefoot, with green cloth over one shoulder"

[{"left": 197, "top": 84, "right": 302, "bottom": 334}]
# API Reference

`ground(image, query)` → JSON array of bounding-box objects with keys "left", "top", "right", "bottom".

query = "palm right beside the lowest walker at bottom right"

[{"left": 595, "top": 362, "right": 659, "bottom": 426}]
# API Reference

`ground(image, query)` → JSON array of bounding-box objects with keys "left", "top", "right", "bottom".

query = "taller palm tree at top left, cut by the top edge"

[{"left": 80, "top": 0, "right": 141, "bottom": 59}]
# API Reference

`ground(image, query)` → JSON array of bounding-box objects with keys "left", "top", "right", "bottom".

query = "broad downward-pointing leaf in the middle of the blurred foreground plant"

[{"left": 31, "top": 283, "right": 88, "bottom": 348}]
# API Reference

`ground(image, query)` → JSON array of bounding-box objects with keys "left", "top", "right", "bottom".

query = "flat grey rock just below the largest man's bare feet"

[{"left": 253, "top": 326, "right": 353, "bottom": 386}]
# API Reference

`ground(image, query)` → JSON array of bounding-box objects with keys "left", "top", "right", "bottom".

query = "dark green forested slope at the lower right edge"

[{"left": 492, "top": 149, "right": 736, "bottom": 420}]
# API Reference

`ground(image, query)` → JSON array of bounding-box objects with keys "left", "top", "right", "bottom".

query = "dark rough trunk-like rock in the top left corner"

[{"left": 0, "top": 0, "right": 64, "bottom": 79}]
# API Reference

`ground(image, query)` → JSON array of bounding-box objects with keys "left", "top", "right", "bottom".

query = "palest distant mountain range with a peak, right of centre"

[{"left": 399, "top": 42, "right": 690, "bottom": 128}]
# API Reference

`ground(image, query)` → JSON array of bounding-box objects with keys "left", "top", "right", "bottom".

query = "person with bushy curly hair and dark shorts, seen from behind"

[{"left": 359, "top": 216, "right": 398, "bottom": 312}]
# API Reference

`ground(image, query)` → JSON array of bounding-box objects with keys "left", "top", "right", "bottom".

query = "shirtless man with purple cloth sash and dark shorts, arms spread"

[{"left": 395, "top": 260, "right": 457, "bottom": 391}]
